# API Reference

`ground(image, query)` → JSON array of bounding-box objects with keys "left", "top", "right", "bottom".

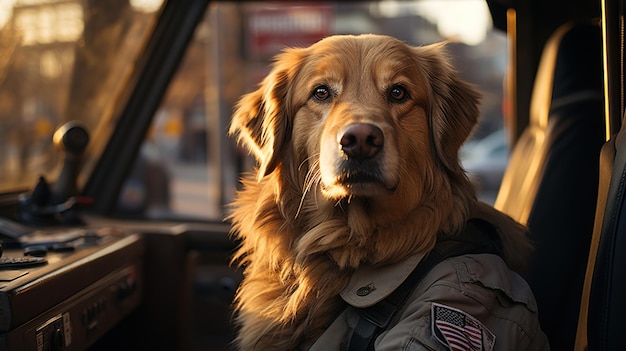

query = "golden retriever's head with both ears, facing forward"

[{"left": 230, "top": 35, "right": 479, "bottom": 223}]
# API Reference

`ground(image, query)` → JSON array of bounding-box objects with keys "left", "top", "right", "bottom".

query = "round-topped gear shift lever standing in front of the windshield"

[{"left": 52, "top": 121, "right": 89, "bottom": 202}]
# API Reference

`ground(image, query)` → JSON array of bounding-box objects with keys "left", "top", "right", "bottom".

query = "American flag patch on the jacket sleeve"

[{"left": 431, "top": 303, "right": 496, "bottom": 351}]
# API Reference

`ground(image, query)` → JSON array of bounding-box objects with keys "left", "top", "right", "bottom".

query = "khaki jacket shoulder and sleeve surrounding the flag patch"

[{"left": 376, "top": 254, "right": 549, "bottom": 350}]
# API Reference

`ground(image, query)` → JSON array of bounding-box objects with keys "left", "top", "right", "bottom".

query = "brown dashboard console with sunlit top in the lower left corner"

[{"left": 0, "top": 228, "right": 144, "bottom": 351}]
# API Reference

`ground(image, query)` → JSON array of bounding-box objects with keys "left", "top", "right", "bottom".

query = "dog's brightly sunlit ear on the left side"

[{"left": 229, "top": 49, "right": 302, "bottom": 180}]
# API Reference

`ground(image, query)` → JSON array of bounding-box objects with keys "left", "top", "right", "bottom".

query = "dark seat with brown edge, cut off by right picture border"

[{"left": 575, "top": 106, "right": 626, "bottom": 351}]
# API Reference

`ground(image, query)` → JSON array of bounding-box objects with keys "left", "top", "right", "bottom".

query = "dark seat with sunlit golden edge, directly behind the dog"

[{"left": 494, "top": 23, "right": 605, "bottom": 351}]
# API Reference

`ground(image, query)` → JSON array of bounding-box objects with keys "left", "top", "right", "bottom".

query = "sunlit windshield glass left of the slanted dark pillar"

[{"left": 0, "top": 0, "right": 162, "bottom": 193}]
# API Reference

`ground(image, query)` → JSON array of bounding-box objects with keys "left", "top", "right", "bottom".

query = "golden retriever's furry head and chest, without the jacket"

[{"left": 229, "top": 35, "right": 530, "bottom": 350}]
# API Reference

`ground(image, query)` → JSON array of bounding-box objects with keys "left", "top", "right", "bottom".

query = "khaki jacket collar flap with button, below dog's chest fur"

[{"left": 340, "top": 253, "right": 426, "bottom": 308}]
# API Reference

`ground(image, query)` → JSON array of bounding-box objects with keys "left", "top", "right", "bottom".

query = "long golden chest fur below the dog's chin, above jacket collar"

[{"left": 227, "top": 175, "right": 456, "bottom": 350}]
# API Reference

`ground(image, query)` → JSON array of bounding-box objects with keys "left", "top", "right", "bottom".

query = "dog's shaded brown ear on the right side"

[{"left": 415, "top": 43, "right": 480, "bottom": 170}]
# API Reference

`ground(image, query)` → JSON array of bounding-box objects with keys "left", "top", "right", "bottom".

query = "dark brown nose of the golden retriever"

[{"left": 338, "top": 123, "right": 385, "bottom": 158}]
